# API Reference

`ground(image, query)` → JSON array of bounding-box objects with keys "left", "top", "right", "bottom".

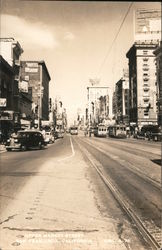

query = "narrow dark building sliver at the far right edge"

[{"left": 154, "top": 42, "right": 162, "bottom": 128}]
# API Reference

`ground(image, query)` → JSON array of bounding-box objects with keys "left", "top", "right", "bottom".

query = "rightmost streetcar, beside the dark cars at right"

[{"left": 108, "top": 125, "right": 127, "bottom": 138}]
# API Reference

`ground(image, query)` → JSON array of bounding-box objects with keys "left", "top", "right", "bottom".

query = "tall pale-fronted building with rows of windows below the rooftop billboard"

[{"left": 126, "top": 41, "right": 157, "bottom": 128}]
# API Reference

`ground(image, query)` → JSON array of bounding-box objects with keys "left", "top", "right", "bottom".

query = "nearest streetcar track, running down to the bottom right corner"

[{"left": 75, "top": 139, "right": 162, "bottom": 250}]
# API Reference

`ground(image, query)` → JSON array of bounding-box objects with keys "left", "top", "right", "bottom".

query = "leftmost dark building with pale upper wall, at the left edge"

[{"left": 0, "top": 38, "right": 23, "bottom": 138}]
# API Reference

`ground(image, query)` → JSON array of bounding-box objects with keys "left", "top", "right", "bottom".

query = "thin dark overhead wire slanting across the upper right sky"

[{"left": 97, "top": 2, "right": 133, "bottom": 76}]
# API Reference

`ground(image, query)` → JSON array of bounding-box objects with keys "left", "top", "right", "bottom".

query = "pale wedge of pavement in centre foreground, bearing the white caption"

[{"left": 0, "top": 144, "right": 126, "bottom": 250}]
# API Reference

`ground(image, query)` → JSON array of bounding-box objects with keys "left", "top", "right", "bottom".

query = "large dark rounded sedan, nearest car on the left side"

[{"left": 6, "top": 130, "right": 47, "bottom": 151}]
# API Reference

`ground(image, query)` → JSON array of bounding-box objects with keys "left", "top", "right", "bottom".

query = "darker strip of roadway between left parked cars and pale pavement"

[{"left": 0, "top": 138, "right": 71, "bottom": 215}]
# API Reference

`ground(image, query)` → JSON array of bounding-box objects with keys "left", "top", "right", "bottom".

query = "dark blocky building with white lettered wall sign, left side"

[{"left": 21, "top": 61, "right": 51, "bottom": 127}]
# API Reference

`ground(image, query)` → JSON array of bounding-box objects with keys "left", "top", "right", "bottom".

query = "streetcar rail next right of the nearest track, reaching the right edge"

[{"left": 81, "top": 139, "right": 161, "bottom": 190}]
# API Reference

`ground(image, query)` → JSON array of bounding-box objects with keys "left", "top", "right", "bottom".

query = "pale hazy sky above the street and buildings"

[{"left": 0, "top": 0, "right": 160, "bottom": 121}]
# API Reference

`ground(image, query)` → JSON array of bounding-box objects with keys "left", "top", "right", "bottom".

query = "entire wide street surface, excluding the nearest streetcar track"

[{"left": 0, "top": 135, "right": 162, "bottom": 250}]
